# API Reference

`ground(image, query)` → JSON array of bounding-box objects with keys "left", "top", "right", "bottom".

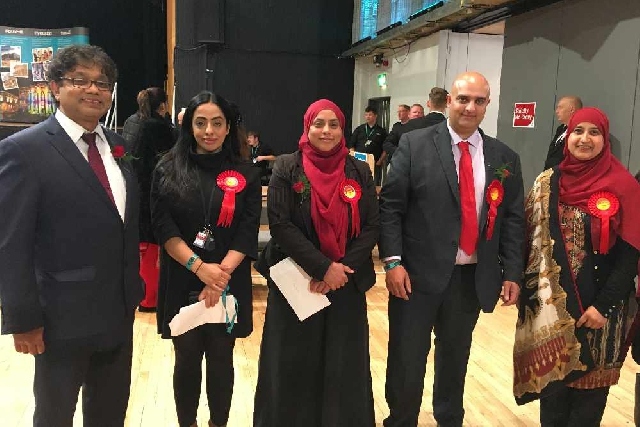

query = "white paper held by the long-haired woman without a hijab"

[{"left": 169, "top": 295, "right": 238, "bottom": 337}]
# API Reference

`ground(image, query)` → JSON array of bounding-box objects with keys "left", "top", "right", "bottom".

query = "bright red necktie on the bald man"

[{"left": 458, "top": 141, "right": 478, "bottom": 255}]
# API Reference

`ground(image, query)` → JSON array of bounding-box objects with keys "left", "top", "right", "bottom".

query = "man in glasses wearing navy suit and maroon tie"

[{"left": 0, "top": 46, "right": 143, "bottom": 427}]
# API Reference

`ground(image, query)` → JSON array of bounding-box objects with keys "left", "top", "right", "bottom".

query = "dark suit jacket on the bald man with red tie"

[{"left": 379, "top": 122, "right": 525, "bottom": 312}]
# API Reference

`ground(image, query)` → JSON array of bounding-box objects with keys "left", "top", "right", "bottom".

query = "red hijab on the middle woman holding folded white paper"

[{"left": 298, "top": 99, "right": 349, "bottom": 261}]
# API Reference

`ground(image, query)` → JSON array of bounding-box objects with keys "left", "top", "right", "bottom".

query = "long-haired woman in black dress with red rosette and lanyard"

[{"left": 151, "top": 92, "right": 262, "bottom": 426}]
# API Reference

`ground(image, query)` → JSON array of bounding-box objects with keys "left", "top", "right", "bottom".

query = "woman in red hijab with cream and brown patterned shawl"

[{"left": 513, "top": 108, "right": 640, "bottom": 427}]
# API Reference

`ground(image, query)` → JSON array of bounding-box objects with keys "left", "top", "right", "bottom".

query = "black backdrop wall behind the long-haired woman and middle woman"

[{"left": 175, "top": 0, "right": 354, "bottom": 154}]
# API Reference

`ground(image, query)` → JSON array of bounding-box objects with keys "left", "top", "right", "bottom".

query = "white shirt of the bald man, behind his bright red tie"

[{"left": 447, "top": 121, "right": 487, "bottom": 264}]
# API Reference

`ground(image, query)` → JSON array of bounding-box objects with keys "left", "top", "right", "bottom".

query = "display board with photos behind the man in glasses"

[{"left": 0, "top": 26, "right": 89, "bottom": 123}]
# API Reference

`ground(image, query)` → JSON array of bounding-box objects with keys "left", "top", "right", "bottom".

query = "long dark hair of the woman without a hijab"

[{"left": 158, "top": 91, "right": 242, "bottom": 195}]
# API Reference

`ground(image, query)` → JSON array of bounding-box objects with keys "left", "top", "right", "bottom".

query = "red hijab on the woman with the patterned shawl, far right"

[{"left": 559, "top": 107, "right": 640, "bottom": 250}]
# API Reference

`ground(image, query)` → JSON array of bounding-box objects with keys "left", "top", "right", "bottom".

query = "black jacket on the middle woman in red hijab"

[{"left": 256, "top": 151, "right": 380, "bottom": 292}]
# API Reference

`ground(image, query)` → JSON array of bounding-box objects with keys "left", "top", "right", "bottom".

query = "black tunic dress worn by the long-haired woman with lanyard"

[{"left": 151, "top": 149, "right": 262, "bottom": 338}]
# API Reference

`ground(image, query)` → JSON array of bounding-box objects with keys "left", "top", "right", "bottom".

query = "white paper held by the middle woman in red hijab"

[{"left": 269, "top": 258, "right": 331, "bottom": 320}]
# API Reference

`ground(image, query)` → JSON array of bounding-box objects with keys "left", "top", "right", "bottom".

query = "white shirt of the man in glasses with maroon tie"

[{"left": 55, "top": 108, "right": 127, "bottom": 221}]
